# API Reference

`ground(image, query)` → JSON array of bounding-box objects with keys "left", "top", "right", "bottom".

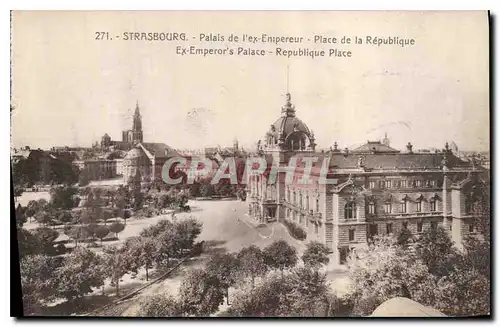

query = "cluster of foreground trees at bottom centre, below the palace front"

[{"left": 137, "top": 241, "right": 333, "bottom": 317}]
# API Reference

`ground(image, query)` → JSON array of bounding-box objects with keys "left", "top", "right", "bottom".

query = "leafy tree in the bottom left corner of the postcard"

[{"left": 20, "top": 255, "right": 60, "bottom": 315}]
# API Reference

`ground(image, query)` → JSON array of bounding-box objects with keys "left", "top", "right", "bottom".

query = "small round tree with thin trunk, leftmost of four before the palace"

[{"left": 206, "top": 253, "right": 239, "bottom": 305}]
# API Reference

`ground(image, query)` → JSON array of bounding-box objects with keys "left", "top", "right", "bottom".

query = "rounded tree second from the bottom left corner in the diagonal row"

[{"left": 56, "top": 246, "right": 104, "bottom": 302}]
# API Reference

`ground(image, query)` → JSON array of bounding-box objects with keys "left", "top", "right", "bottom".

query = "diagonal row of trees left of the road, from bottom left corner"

[{"left": 20, "top": 218, "right": 202, "bottom": 314}]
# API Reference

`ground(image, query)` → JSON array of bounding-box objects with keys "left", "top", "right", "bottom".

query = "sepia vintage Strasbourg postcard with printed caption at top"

[{"left": 11, "top": 11, "right": 491, "bottom": 318}]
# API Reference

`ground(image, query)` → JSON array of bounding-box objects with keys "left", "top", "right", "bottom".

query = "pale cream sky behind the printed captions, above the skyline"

[{"left": 12, "top": 11, "right": 490, "bottom": 150}]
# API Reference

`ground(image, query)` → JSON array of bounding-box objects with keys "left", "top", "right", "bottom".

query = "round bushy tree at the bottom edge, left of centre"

[{"left": 179, "top": 269, "right": 224, "bottom": 317}]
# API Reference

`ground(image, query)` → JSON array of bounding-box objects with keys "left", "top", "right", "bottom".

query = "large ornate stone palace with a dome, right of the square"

[{"left": 247, "top": 94, "right": 484, "bottom": 264}]
